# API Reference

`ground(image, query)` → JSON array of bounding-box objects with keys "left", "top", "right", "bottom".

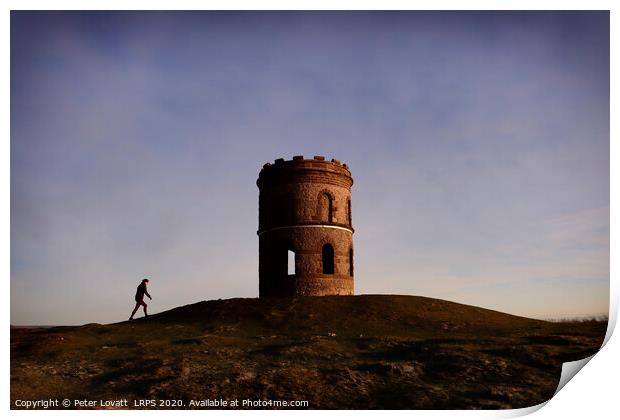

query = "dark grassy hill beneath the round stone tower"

[{"left": 11, "top": 295, "right": 606, "bottom": 409}]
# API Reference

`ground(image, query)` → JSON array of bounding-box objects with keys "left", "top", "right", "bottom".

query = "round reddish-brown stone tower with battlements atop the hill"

[{"left": 256, "top": 156, "right": 353, "bottom": 297}]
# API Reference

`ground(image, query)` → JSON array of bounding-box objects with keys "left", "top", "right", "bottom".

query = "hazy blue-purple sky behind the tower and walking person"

[{"left": 10, "top": 11, "right": 610, "bottom": 325}]
